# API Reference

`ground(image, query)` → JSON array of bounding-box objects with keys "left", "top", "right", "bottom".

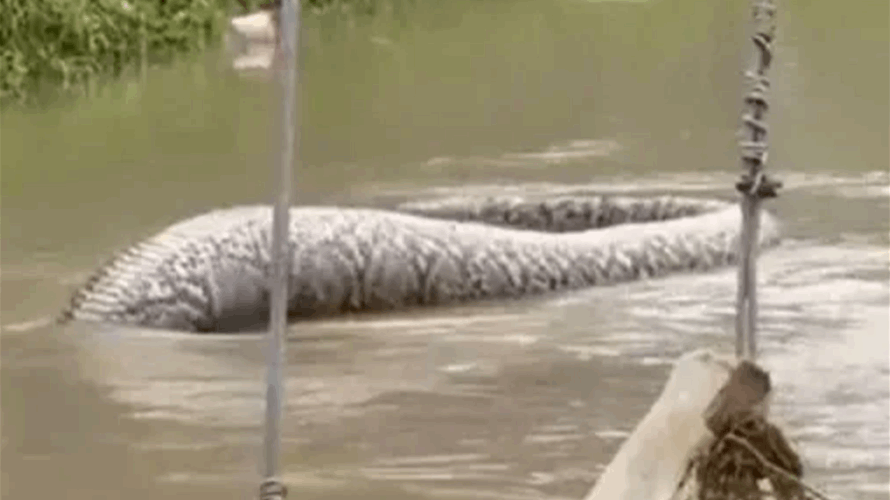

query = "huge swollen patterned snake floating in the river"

[{"left": 60, "top": 196, "right": 779, "bottom": 332}]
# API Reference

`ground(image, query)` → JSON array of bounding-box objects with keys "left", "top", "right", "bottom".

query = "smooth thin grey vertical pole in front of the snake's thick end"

[{"left": 260, "top": 0, "right": 300, "bottom": 500}]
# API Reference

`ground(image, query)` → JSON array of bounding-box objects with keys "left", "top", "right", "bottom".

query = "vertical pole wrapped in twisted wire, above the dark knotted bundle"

[{"left": 735, "top": 0, "right": 781, "bottom": 361}]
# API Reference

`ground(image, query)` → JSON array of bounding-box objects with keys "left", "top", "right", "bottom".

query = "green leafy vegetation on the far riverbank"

[{"left": 0, "top": 0, "right": 402, "bottom": 104}]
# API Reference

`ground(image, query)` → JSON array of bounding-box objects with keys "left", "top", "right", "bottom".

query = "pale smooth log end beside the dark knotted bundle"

[{"left": 585, "top": 350, "right": 734, "bottom": 500}]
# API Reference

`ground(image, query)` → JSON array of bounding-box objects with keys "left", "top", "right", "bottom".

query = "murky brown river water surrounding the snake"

[{"left": 0, "top": 0, "right": 890, "bottom": 499}]
